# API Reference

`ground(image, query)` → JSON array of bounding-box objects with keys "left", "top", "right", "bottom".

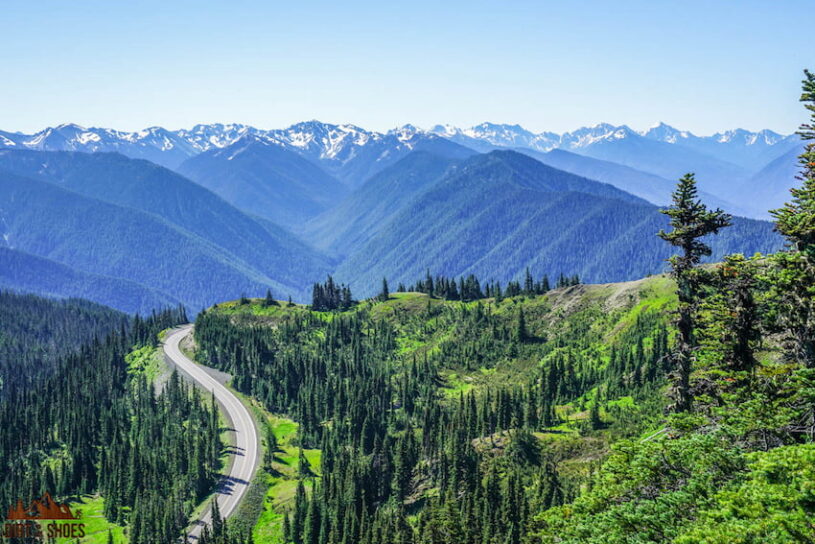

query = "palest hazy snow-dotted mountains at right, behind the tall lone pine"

[{"left": 430, "top": 123, "right": 799, "bottom": 217}]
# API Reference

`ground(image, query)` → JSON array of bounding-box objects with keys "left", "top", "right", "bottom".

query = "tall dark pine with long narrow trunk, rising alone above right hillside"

[{"left": 658, "top": 174, "right": 731, "bottom": 412}]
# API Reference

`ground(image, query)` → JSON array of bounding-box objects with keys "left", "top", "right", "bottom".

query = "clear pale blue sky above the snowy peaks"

[{"left": 0, "top": 0, "right": 815, "bottom": 134}]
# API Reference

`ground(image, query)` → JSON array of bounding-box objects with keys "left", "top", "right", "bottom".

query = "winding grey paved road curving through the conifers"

[{"left": 164, "top": 325, "right": 259, "bottom": 542}]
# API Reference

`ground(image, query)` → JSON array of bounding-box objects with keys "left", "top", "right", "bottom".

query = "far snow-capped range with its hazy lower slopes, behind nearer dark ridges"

[{"left": 0, "top": 121, "right": 801, "bottom": 216}]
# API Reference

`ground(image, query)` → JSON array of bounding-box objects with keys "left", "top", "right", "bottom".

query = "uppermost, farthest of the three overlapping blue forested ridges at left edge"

[{"left": 0, "top": 147, "right": 329, "bottom": 286}]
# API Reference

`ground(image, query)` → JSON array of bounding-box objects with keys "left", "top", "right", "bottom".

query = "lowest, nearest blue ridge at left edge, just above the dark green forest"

[{"left": 0, "top": 246, "right": 180, "bottom": 314}]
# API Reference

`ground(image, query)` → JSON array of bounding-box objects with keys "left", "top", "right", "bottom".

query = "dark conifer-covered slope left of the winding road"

[{"left": 0, "top": 302, "right": 236, "bottom": 544}]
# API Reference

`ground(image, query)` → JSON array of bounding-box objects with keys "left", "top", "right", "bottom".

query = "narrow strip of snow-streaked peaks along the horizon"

[{"left": 0, "top": 120, "right": 798, "bottom": 171}]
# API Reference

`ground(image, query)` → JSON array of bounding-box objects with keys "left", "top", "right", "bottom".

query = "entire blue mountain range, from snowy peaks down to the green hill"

[{"left": 0, "top": 121, "right": 801, "bottom": 312}]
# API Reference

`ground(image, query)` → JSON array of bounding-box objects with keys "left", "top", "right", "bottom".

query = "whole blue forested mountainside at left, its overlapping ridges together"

[{"left": 0, "top": 151, "right": 329, "bottom": 310}]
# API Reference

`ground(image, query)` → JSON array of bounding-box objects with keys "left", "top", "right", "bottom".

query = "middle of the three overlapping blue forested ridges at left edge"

[{"left": 0, "top": 166, "right": 316, "bottom": 309}]
